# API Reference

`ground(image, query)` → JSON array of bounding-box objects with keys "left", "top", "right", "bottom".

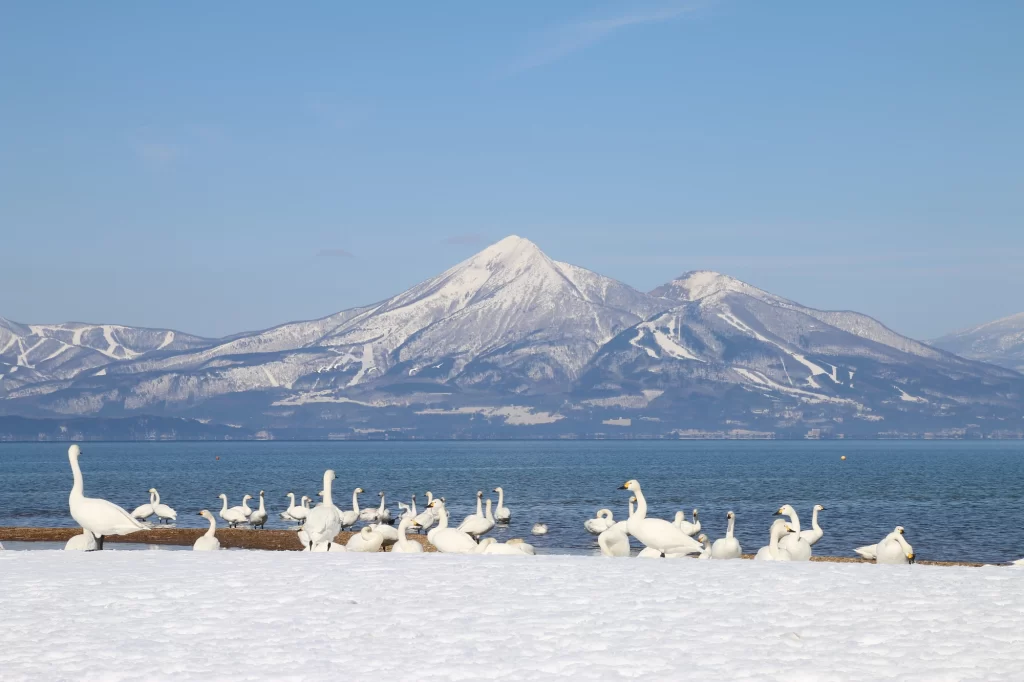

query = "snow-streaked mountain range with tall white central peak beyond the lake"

[{"left": 0, "top": 237, "right": 1024, "bottom": 438}]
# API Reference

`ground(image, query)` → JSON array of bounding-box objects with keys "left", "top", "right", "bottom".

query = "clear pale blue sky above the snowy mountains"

[{"left": 0, "top": 0, "right": 1024, "bottom": 338}]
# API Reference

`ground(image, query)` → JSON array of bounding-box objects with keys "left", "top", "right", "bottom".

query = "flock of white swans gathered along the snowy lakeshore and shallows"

[{"left": 6, "top": 444, "right": 914, "bottom": 563}]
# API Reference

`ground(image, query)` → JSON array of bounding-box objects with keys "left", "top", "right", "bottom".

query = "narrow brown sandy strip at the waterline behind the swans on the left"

[{"left": 0, "top": 526, "right": 435, "bottom": 552}]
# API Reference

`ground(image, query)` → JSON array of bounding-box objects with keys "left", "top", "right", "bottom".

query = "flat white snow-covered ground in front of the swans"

[{"left": 0, "top": 551, "right": 1024, "bottom": 682}]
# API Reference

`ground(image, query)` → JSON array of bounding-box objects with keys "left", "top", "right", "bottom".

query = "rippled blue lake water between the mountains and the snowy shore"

[{"left": 0, "top": 441, "right": 1024, "bottom": 562}]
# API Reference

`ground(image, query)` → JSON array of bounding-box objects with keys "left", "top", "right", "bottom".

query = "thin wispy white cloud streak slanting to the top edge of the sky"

[{"left": 509, "top": 4, "right": 697, "bottom": 74}]
